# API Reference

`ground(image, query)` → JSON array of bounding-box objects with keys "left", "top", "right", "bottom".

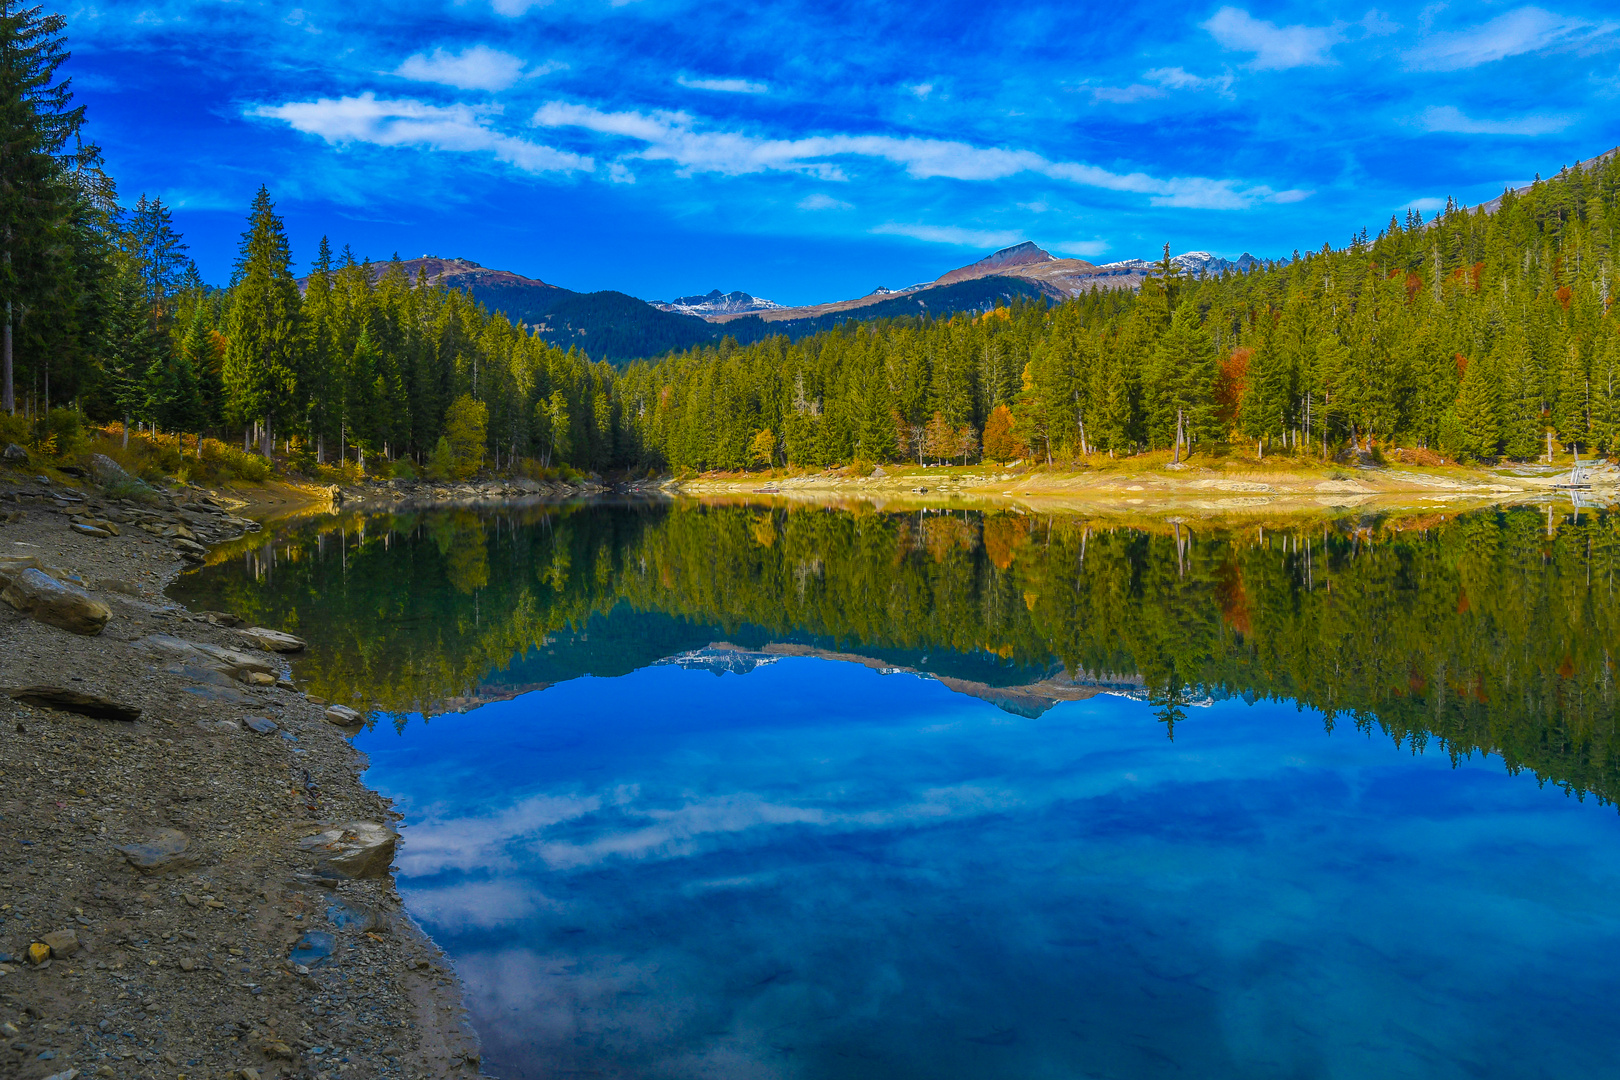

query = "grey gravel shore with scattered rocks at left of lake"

[{"left": 0, "top": 471, "right": 480, "bottom": 1080}]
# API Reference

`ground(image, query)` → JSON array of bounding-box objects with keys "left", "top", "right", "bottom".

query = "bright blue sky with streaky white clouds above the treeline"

[{"left": 63, "top": 0, "right": 1620, "bottom": 303}]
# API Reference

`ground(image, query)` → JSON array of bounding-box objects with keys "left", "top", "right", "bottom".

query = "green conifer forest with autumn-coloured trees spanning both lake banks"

[{"left": 0, "top": 10, "right": 1620, "bottom": 474}]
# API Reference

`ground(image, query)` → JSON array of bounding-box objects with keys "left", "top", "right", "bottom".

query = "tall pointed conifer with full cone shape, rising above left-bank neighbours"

[{"left": 224, "top": 186, "right": 303, "bottom": 458}]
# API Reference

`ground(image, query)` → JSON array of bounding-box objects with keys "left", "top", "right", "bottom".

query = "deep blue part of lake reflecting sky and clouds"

[{"left": 360, "top": 659, "right": 1620, "bottom": 1078}]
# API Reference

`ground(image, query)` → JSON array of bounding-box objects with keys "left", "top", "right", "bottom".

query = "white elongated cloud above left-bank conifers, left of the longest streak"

[{"left": 246, "top": 92, "right": 596, "bottom": 173}]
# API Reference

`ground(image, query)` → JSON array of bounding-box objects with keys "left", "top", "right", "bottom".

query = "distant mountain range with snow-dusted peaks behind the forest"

[{"left": 298, "top": 243, "right": 1259, "bottom": 361}]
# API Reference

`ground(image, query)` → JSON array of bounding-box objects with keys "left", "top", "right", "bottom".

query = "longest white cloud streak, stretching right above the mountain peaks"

[{"left": 535, "top": 102, "right": 1288, "bottom": 209}]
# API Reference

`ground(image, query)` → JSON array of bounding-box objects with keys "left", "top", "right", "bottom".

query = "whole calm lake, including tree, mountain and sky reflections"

[{"left": 173, "top": 502, "right": 1620, "bottom": 1080}]
